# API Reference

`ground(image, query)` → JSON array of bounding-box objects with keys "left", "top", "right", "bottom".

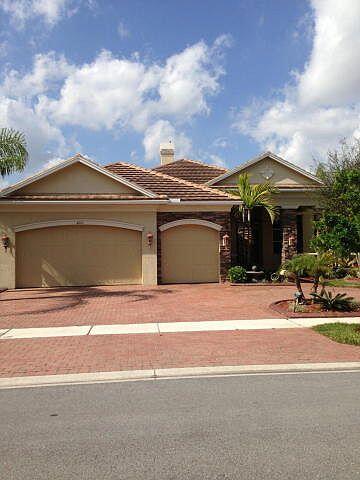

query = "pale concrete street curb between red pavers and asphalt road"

[{"left": 0, "top": 362, "right": 360, "bottom": 390}]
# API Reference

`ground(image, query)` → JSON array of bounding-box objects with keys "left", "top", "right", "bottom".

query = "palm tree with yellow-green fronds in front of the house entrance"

[{"left": 231, "top": 173, "right": 278, "bottom": 263}]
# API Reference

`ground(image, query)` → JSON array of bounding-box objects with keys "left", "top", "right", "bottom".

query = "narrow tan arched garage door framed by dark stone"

[{"left": 161, "top": 225, "right": 219, "bottom": 283}]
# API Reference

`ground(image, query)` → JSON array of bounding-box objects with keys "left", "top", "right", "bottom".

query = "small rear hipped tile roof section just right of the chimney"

[{"left": 153, "top": 158, "right": 227, "bottom": 184}]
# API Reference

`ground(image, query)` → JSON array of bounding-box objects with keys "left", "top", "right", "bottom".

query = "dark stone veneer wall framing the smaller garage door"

[{"left": 157, "top": 212, "right": 231, "bottom": 283}]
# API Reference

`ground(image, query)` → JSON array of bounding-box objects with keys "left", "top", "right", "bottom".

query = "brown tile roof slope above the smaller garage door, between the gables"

[{"left": 105, "top": 162, "right": 238, "bottom": 202}]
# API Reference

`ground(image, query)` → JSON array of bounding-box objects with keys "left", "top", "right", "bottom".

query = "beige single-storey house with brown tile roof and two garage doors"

[{"left": 0, "top": 144, "right": 321, "bottom": 288}]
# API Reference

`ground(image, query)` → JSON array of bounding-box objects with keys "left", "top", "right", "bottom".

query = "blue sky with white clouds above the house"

[{"left": 0, "top": 0, "right": 360, "bottom": 186}]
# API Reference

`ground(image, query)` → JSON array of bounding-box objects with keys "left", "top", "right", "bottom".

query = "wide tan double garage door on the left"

[{"left": 16, "top": 225, "right": 142, "bottom": 288}]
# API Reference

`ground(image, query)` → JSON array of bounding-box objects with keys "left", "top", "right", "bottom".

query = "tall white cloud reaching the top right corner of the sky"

[{"left": 234, "top": 0, "right": 360, "bottom": 168}]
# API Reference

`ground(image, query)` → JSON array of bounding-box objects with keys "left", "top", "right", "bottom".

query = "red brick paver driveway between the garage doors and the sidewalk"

[{"left": 0, "top": 284, "right": 306, "bottom": 328}]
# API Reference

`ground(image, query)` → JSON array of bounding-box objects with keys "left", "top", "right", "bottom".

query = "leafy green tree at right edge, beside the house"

[{"left": 311, "top": 141, "right": 360, "bottom": 270}]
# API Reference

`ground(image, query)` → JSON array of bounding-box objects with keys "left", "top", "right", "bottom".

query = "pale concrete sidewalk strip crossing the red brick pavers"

[{"left": 0, "top": 317, "right": 360, "bottom": 340}]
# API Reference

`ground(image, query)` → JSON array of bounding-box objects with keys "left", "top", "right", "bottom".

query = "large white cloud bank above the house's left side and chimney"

[{"left": 0, "top": 36, "right": 228, "bottom": 168}]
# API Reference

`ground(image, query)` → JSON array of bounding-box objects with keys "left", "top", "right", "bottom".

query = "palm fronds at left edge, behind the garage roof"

[{"left": 0, "top": 128, "right": 28, "bottom": 177}]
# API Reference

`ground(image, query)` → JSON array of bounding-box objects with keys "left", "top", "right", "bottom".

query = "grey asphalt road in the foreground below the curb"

[{"left": 0, "top": 373, "right": 360, "bottom": 480}]
